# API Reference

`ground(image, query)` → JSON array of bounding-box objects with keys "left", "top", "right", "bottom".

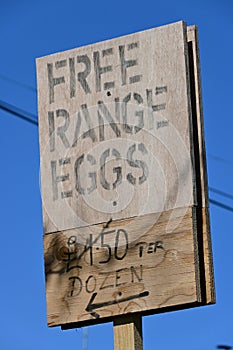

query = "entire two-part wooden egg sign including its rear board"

[{"left": 37, "top": 22, "right": 214, "bottom": 328}]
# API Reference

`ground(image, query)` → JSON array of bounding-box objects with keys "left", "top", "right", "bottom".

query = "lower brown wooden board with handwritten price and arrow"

[{"left": 44, "top": 208, "right": 204, "bottom": 326}]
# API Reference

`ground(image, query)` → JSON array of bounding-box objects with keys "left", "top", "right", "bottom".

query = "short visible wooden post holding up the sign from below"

[{"left": 114, "top": 314, "right": 143, "bottom": 350}]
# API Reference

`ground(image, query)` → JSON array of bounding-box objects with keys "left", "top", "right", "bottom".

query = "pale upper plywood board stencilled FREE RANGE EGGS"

[{"left": 37, "top": 22, "right": 193, "bottom": 233}]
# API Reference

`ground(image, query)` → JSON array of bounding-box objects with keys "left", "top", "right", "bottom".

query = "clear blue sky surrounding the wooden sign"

[{"left": 0, "top": 0, "right": 233, "bottom": 350}]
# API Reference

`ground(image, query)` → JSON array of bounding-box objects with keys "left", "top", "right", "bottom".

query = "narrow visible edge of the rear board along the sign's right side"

[{"left": 187, "top": 26, "right": 215, "bottom": 304}]
